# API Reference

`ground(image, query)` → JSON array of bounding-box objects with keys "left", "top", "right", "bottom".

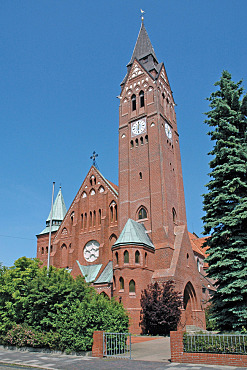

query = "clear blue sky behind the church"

[{"left": 0, "top": 0, "right": 247, "bottom": 266}]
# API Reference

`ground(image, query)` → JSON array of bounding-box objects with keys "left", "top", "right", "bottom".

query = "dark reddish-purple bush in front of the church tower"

[{"left": 141, "top": 280, "right": 182, "bottom": 335}]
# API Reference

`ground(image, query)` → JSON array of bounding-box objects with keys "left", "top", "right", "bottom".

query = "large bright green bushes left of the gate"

[{"left": 0, "top": 257, "right": 129, "bottom": 351}]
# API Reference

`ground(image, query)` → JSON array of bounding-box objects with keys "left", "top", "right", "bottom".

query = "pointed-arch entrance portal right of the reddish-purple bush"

[{"left": 183, "top": 281, "right": 196, "bottom": 326}]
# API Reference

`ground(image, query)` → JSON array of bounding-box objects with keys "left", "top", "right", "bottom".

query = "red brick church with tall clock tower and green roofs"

[{"left": 37, "top": 22, "right": 209, "bottom": 333}]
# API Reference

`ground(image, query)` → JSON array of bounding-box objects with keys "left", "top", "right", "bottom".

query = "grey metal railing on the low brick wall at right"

[{"left": 183, "top": 333, "right": 247, "bottom": 355}]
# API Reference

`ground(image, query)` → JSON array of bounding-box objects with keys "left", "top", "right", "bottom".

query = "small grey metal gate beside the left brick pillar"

[{"left": 103, "top": 332, "right": 131, "bottom": 359}]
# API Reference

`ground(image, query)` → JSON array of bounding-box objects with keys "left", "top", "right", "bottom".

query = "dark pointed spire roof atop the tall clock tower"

[{"left": 128, "top": 22, "right": 158, "bottom": 66}]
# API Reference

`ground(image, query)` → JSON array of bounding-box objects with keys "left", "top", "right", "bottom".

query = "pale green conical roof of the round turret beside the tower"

[{"left": 113, "top": 218, "right": 154, "bottom": 249}]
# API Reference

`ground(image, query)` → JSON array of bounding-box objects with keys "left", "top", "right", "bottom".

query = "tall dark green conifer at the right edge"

[{"left": 203, "top": 71, "right": 247, "bottom": 330}]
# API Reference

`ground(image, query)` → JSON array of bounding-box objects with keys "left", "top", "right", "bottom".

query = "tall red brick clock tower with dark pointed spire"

[{"left": 119, "top": 22, "right": 186, "bottom": 269}]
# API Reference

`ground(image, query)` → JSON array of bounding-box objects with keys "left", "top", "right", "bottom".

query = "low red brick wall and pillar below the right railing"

[{"left": 170, "top": 331, "right": 247, "bottom": 367}]
